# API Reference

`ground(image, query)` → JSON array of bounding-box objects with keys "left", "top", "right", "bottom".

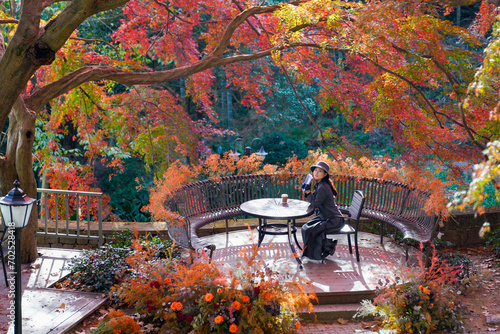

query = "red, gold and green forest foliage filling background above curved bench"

[{"left": 0, "top": 1, "right": 499, "bottom": 230}]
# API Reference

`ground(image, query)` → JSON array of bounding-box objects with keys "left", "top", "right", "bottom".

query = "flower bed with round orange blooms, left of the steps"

[{"left": 111, "top": 241, "right": 315, "bottom": 333}]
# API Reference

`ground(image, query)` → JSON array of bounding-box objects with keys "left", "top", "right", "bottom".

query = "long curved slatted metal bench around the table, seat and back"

[{"left": 165, "top": 174, "right": 437, "bottom": 258}]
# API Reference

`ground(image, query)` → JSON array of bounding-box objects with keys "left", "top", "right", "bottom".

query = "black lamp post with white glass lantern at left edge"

[{"left": 0, "top": 180, "right": 36, "bottom": 334}]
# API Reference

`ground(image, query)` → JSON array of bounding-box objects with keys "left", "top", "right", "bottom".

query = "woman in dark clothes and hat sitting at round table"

[{"left": 302, "top": 161, "right": 344, "bottom": 261}]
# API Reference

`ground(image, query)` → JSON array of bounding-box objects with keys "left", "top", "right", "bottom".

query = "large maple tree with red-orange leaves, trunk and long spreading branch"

[{"left": 0, "top": 0, "right": 498, "bottom": 261}]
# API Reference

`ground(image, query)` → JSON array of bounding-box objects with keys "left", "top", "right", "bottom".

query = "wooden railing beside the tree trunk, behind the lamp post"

[{"left": 37, "top": 188, "right": 103, "bottom": 246}]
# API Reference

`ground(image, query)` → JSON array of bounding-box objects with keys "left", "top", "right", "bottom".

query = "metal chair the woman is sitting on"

[{"left": 325, "top": 190, "right": 365, "bottom": 262}]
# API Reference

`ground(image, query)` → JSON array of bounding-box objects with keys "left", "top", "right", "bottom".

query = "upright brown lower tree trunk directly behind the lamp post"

[{"left": 0, "top": 98, "right": 38, "bottom": 263}]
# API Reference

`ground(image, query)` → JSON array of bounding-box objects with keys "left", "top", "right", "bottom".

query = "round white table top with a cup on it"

[{"left": 240, "top": 198, "right": 314, "bottom": 219}]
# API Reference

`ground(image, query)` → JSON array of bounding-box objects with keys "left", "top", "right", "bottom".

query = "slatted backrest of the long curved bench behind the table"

[{"left": 166, "top": 174, "right": 429, "bottom": 219}]
